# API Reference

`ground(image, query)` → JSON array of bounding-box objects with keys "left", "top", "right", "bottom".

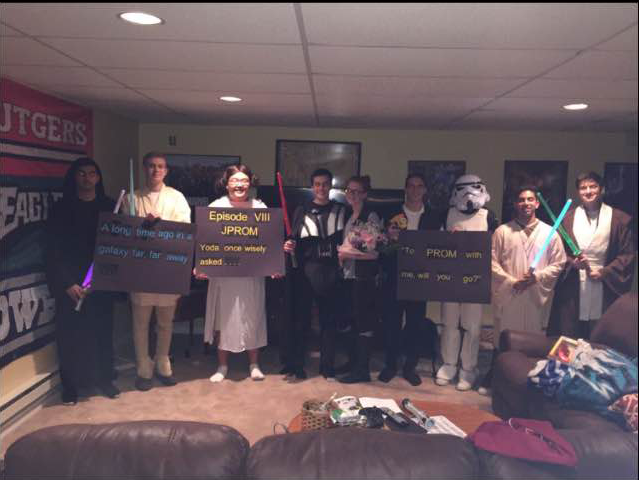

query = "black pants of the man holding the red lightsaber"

[{"left": 282, "top": 268, "right": 339, "bottom": 369}]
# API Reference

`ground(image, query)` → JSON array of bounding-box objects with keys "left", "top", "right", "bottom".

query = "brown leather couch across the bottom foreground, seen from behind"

[{"left": 2, "top": 421, "right": 637, "bottom": 480}]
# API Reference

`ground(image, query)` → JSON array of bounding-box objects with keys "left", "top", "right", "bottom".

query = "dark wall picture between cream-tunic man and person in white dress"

[{"left": 165, "top": 154, "right": 241, "bottom": 207}]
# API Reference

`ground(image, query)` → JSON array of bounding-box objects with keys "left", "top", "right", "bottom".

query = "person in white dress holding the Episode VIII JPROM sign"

[{"left": 194, "top": 165, "right": 267, "bottom": 383}]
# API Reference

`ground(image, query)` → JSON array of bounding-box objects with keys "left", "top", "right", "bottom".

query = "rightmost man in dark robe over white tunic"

[{"left": 548, "top": 172, "right": 635, "bottom": 340}]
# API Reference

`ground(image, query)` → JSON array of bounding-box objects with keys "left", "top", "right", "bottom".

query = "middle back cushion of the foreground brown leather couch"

[{"left": 247, "top": 427, "right": 479, "bottom": 479}]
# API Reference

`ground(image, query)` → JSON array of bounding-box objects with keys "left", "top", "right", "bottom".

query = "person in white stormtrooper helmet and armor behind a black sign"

[{"left": 435, "top": 175, "right": 491, "bottom": 391}]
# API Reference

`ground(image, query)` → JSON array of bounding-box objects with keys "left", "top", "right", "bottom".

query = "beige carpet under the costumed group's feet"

[{"left": 0, "top": 335, "right": 491, "bottom": 456}]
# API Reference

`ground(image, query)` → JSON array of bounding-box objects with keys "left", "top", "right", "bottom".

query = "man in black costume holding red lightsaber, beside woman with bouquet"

[{"left": 282, "top": 168, "right": 346, "bottom": 380}]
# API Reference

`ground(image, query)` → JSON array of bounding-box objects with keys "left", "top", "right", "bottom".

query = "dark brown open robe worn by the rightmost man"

[{"left": 548, "top": 208, "right": 635, "bottom": 338}]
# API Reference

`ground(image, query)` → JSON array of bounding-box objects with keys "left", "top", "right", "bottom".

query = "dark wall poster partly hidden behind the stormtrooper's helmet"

[{"left": 408, "top": 160, "right": 466, "bottom": 210}]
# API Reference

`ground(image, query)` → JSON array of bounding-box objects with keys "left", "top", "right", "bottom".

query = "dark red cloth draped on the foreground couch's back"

[{"left": 467, "top": 418, "right": 577, "bottom": 467}]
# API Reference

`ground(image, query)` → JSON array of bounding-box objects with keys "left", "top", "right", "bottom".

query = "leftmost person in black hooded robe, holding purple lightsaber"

[{"left": 46, "top": 158, "right": 120, "bottom": 405}]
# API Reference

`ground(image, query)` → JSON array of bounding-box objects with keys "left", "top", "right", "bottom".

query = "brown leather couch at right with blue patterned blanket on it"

[{"left": 492, "top": 293, "right": 637, "bottom": 478}]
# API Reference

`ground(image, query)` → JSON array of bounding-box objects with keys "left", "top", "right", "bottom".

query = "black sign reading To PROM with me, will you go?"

[{"left": 397, "top": 230, "right": 491, "bottom": 303}]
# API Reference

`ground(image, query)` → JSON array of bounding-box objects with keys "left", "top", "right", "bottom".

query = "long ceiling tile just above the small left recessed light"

[{"left": 101, "top": 68, "right": 310, "bottom": 93}]
